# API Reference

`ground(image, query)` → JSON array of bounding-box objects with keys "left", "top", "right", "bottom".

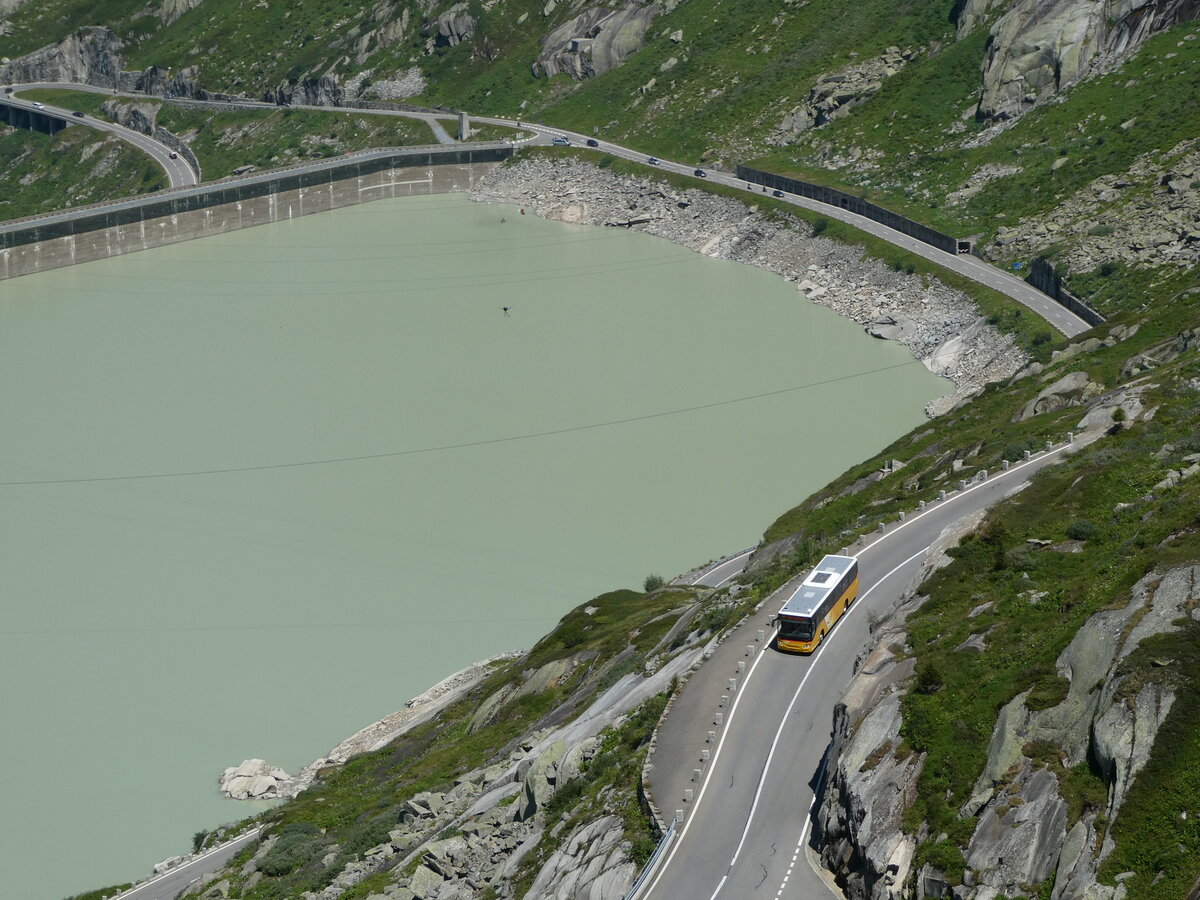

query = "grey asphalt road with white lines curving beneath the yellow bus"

[{"left": 640, "top": 446, "right": 1084, "bottom": 900}]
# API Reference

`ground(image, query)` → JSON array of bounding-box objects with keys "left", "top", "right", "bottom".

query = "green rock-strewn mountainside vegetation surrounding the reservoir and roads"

[{"left": 0, "top": 0, "right": 1200, "bottom": 900}]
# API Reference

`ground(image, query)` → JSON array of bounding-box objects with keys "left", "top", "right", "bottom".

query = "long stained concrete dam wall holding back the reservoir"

[{"left": 0, "top": 143, "right": 512, "bottom": 278}]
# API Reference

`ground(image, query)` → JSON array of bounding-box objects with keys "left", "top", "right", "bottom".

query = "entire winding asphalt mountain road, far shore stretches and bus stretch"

[{"left": 6, "top": 84, "right": 1104, "bottom": 900}]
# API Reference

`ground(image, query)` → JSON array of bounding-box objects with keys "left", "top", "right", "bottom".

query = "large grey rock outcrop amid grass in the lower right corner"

[{"left": 958, "top": 566, "right": 1200, "bottom": 900}]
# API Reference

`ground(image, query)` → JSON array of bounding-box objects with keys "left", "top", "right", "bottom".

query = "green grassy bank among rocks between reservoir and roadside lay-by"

[{"left": 166, "top": 580, "right": 752, "bottom": 900}]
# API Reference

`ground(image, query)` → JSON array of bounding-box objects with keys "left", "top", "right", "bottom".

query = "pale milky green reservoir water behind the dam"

[{"left": 0, "top": 196, "right": 946, "bottom": 900}]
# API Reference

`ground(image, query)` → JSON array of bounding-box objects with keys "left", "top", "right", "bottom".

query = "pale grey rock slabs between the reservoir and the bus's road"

[{"left": 190, "top": 643, "right": 704, "bottom": 900}]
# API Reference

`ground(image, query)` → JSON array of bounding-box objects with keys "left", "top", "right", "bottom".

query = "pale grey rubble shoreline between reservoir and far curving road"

[{"left": 472, "top": 157, "right": 1028, "bottom": 416}]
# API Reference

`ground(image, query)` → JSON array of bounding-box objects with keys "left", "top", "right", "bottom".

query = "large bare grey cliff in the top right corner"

[{"left": 979, "top": 0, "right": 1200, "bottom": 121}]
